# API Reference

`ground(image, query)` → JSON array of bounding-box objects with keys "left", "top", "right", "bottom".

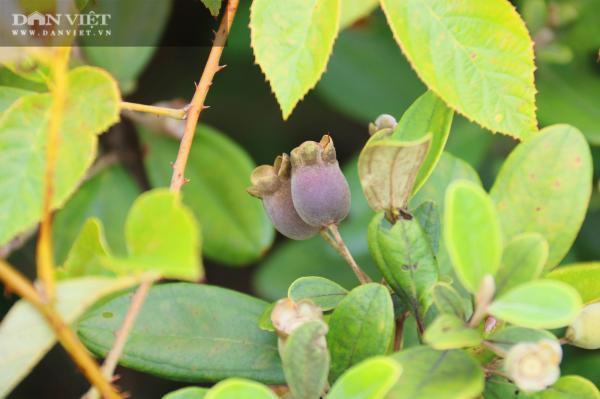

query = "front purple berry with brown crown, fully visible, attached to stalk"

[{"left": 291, "top": 135, "right": 350, "bottom": 227}]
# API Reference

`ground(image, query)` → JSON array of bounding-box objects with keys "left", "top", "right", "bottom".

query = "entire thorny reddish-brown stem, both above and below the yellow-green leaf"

[{"left": 95, "top": 0, "right": 239, "bottom": 394}]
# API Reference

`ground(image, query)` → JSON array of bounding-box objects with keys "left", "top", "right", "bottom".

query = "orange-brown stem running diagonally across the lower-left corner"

[{"left": 0, "top": 260, "right": 121, "bottom": 399}]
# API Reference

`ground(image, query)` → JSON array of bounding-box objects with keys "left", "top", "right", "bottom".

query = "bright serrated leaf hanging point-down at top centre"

[{"left": 250, "top": 0, "right": 340, "bottom": 119}]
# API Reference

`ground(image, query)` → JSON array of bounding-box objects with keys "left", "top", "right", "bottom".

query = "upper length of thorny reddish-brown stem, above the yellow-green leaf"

[{"left": 171, "top": 0, "right": 239, "bottom": 193}]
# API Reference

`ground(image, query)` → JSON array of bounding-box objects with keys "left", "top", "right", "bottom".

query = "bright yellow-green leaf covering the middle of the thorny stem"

[{"left": 111, "top": 189, "right": 204, "bottom": 281}]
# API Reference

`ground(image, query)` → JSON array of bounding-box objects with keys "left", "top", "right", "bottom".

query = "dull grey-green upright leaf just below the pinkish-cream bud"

[{"left": 281, "top": 321, "right": 329, "bottom": 399}]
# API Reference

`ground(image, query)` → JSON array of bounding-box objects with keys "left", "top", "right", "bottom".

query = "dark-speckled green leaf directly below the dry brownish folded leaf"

[{"left": 369, "top": 214, "right": 438, "bottom": 319}]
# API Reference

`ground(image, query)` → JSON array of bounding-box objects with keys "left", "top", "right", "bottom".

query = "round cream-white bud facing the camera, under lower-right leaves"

[{"left": 504, "top": 339, "right": 562, "bottom": 392}]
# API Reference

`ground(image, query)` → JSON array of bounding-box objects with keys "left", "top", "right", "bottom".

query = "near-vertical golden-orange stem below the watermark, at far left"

[{"left": 36, "top": 47, "right": 71, "bottom": 301}]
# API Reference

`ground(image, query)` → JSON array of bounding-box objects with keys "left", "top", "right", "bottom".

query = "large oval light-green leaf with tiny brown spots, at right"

[{"left": 490, "top": 125, "right": 592, "bottom": 270}]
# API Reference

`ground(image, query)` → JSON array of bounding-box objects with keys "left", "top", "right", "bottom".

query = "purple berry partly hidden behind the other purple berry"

[{"left": 247, "top": 154, "right": 319, "bottom": 240}]
